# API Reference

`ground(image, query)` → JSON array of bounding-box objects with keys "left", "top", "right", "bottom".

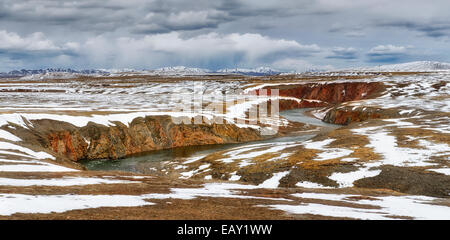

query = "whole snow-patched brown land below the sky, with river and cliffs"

[{"left": 0, "top": 61, "right": 450, "bottom": 220}]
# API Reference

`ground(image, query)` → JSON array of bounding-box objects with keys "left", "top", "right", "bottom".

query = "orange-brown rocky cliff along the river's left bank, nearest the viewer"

[{"left": 16, "top": 116, "right": 264, "bottom": 161}]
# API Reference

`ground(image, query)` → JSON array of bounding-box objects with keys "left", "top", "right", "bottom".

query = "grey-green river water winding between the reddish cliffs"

[{"left": 81, "top": 108, "right": 338, "bottom": 173}]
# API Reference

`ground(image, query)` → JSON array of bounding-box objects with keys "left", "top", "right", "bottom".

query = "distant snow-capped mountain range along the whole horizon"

[{"left": 0, "top": 61, "right": 450, "bottom": 79}]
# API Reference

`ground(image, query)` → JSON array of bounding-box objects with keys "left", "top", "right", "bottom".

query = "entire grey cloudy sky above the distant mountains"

[{"left": 0, "top": 0, "right": 450, "bottom": 71}]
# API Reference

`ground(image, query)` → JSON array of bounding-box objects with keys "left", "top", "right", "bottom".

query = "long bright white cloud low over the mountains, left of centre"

[{"left": 77, "top": 32, "right": 321, "bottom": 67}]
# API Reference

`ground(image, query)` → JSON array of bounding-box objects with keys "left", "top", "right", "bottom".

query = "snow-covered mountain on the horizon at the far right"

[{"left": 353, "top": 61, "right": 450, "bottom": 72}]
